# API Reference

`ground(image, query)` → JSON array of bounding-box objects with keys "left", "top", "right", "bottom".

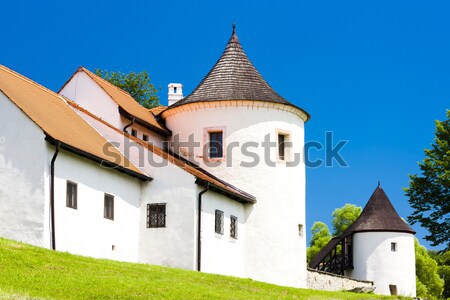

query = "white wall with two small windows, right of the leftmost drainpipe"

[{"left": 48, "top": 146, "right": 140, "bottom": 262}]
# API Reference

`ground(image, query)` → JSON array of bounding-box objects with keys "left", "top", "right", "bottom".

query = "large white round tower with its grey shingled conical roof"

[{"left": 161, "top": 28, "right": 309, "bottom": 287}]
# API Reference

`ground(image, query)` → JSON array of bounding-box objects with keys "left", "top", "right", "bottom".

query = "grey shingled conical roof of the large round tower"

[{"left": 168, "top": 26, "right": 309, "bottom": 118}]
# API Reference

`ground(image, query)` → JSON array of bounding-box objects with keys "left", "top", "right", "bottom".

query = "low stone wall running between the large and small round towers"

[{"left": 307, "top": 268, "right": 374, "bottom": 292}]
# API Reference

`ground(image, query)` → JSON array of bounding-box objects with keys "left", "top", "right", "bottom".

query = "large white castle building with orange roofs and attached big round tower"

[{"left": 0, "top": 30, "right": 309, "bottom": 287}]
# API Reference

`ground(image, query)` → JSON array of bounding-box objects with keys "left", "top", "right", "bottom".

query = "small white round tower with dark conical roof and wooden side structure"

[{"left": 309, "top": 186, "right": 416, "bottom": 297}]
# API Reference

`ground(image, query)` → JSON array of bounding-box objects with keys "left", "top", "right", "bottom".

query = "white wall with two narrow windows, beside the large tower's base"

[{"left": 201, "top": 191, "right": 246, "bottom": 277}]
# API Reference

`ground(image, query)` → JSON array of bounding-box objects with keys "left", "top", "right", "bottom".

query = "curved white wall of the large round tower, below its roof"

[{"left": 166, "top": 101, "right": 306, "bottom": 287}]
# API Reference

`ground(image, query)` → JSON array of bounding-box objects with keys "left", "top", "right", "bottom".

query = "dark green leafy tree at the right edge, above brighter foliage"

[{"left": 405, "top": 110, "right": 450, "bottom": 250}]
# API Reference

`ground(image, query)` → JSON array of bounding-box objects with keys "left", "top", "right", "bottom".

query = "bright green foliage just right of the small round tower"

[{"left": 414, "top": 239, "right": 444, "bottom": 299}]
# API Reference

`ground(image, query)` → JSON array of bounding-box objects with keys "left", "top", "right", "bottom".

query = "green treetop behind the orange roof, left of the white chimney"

[{"left": 95, "top": 69, "right": 160, "bottom": 108}]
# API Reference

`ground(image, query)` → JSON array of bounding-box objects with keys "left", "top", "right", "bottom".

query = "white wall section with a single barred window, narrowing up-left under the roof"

[{"left": 66, "top": 110, "right": 198, "bottom": 270}]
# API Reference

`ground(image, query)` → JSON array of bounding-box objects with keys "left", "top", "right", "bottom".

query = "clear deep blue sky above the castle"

[{"left": 0, "top": 0, "right": 450, "bottom": 247}]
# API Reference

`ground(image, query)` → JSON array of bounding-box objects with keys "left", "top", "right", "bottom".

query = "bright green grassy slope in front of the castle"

[{"left": 0, "top": 239, "right": 400, "bottom": 299}]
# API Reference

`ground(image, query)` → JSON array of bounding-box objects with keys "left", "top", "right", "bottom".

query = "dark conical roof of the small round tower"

[{"left": 344, "top": 186, "right": 416, "bottom": 234}]
